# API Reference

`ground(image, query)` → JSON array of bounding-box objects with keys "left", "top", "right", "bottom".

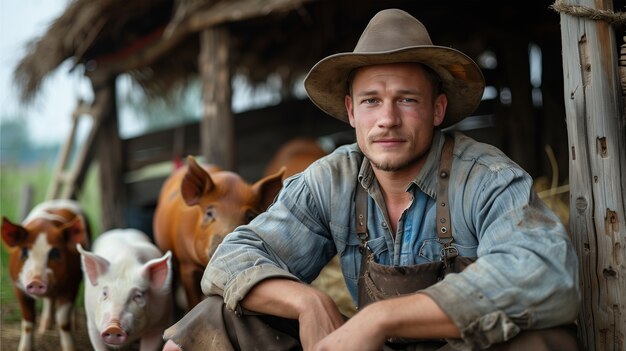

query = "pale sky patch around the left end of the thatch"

[{"left": 0, "top": 0, "right": 93, "bottom": 144}]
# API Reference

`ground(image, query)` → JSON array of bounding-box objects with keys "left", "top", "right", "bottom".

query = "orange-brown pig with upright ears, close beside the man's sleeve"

[{"left": 153, "top": 156, "right": 283, "bottom": 309}]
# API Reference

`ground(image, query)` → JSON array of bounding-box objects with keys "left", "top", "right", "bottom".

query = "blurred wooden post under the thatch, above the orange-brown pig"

[{"left": 198, "top": 27, "right": 236, "bottom": 170}]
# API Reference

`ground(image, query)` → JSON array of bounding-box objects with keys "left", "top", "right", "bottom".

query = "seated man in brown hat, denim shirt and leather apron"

[{"left": 165, "top": 9, "right": 580, "bottom": 351}]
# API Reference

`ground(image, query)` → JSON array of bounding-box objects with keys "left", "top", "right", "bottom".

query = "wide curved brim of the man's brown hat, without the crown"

[{"left": 304, "top": 45, "right": 485, "bottom": 128}]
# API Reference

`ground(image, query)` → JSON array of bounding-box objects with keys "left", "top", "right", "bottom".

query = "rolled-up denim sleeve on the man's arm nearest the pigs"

[{"left": 201, "top": 175, "right": 336, "bottom": 310}]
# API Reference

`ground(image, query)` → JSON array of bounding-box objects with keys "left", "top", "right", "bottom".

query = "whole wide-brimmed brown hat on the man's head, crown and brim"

[{"left": 304, "top": 9, "right": 485, "bottom": 128}]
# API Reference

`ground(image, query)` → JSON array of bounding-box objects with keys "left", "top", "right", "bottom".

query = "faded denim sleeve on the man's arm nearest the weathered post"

[{"left": 422, "top": 167, "right": 580, "bottom": 349}]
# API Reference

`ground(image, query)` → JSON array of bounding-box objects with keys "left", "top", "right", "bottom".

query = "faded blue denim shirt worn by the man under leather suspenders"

[{"left": 202, "top": 131, "right": 580, "bottom": 348}]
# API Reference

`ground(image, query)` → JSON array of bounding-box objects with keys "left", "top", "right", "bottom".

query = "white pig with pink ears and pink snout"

[{"left": 77, "top": 229, "right": 173, "bottom": 351}]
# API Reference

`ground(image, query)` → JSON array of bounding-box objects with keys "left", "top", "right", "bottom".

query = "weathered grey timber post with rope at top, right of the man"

[{"left": 561, "top": 0, "right": 626, "bottom": 350}]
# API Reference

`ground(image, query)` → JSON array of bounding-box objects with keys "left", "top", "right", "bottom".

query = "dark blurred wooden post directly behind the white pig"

[{"left": 90, "top": 76, "right": 126, "bottom": 231}]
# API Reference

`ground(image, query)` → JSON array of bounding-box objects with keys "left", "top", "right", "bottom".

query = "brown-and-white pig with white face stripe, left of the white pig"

[{"left": 2, "top": 200, "right": 91, "bottom": 351}]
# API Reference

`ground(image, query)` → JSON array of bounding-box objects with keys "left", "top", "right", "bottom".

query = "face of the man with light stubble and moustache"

[{"left": 345, "top": 63, "right": 447, "bottom": 172}]
